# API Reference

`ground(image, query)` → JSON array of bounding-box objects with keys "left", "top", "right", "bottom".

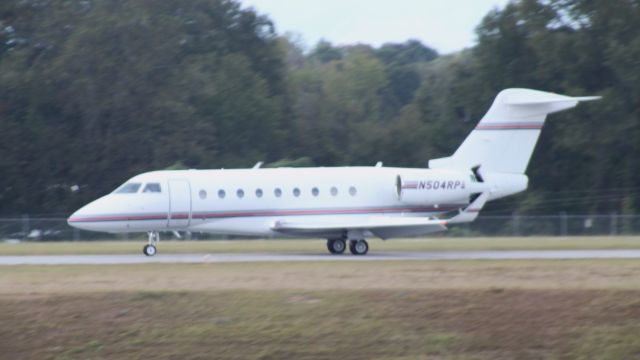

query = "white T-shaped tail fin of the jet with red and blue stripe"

[{"left": 429, "top": 89, "right": 600, "bottom": 174}]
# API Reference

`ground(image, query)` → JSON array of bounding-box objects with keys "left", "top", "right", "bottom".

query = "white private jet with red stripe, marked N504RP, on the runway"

[{"left": 68, "top": 89, "right": 599, "bottom": 256}]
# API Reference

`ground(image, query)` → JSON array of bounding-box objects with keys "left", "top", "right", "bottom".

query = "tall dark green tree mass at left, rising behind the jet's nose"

[{"left": 0, "top": 0, "right": 287, "bottom": 214}]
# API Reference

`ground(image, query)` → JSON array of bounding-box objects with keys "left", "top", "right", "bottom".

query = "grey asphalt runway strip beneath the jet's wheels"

[{"left": 0, "top": 249, "right": 640, "bottom": 266}]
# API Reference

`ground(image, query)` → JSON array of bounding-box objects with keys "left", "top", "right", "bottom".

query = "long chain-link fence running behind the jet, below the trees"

[{"left": 0, "top": 214, "right": 640, "bottom": 241}]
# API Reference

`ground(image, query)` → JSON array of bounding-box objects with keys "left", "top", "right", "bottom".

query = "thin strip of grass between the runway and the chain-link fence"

[{"left": 0, "top": 236, "right": 640, "bottom": 256}]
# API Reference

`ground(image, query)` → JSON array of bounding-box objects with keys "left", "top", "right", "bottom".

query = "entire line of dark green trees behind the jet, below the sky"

[{"left": 0, "top": 0, "right": 640, "bottom": 216}]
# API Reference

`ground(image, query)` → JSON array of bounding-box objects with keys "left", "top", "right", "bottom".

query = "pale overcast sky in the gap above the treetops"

[{"left": 241, "top": 0, "right": 509, "bottom": 54}]
